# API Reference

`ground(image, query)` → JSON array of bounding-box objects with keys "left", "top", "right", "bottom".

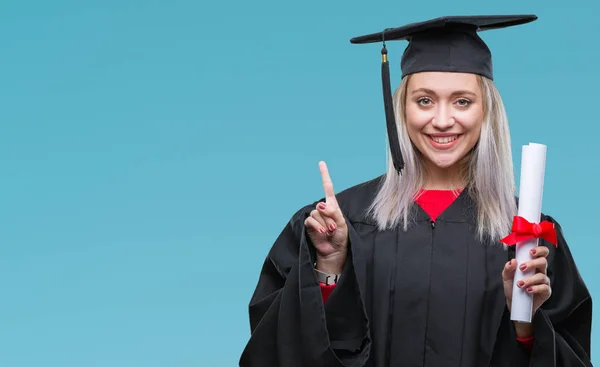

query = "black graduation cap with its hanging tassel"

[{"left": 350, "top": 15, "right": 537, "bottom": 173}]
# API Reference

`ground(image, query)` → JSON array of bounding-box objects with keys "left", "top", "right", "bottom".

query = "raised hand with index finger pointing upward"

[{"left": 304, "top": 162, "right": 348, "bottom": 274}]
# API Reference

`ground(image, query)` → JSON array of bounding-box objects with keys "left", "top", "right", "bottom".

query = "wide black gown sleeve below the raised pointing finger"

[{"left": 240, "top": 207, "right": 371, "bottom": 367}]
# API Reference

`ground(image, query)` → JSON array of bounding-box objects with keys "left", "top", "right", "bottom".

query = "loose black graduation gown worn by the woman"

[{"left": 240, "top": 176, "right": 592, "bottom": 367}]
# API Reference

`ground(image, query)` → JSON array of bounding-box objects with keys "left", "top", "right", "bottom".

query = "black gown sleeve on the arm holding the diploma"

[{"left": 497, "top": 216, "right": 592, "bottom": 367}]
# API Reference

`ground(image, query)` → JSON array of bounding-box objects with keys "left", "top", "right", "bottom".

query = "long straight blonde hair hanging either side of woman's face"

[{"left": 369, "top": 76, "right": 517, "bottom": 240}]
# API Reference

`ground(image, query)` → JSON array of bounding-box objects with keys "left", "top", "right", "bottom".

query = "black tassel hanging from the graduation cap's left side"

[{"left": 381, "top": 41, "right": 404, "bottom": 174}]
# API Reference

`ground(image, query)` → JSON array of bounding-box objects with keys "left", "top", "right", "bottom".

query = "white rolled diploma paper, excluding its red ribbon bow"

[{"left": 510, "top": 143, "right": 546, "bottom": 323}]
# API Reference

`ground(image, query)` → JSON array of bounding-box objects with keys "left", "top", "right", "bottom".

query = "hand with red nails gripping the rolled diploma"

[{"left": 502, "top": 246, "right": 552, "bottom": 336}]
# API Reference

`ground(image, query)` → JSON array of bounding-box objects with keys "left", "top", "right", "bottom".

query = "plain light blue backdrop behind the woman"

[{"left": 0, "top": 0, "right": 600, "bottom": 367}]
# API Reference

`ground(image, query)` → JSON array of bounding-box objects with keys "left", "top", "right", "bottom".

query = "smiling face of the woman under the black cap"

[{"left": 405, "top": 72, "right": 484, "bottom": 172}]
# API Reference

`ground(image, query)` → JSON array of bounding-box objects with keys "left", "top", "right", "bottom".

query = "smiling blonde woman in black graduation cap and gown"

[{"left": 240, "top": 16, "right": 592, "bottom": 367}]
